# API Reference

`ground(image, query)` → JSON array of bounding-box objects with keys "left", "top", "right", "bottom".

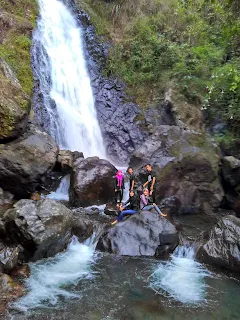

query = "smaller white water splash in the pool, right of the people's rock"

[{"left": 150, "top": 246, "right": 211, "bottom": 304}]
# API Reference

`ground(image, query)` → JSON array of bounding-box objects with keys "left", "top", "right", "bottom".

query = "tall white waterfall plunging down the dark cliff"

[{"left": 32, "top": 0, "right": 106, "bottom": 158}]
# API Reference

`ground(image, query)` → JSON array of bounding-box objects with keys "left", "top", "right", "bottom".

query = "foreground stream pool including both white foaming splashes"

[{"left": 9, "top": 234, "right": 240, "bottom": 320}]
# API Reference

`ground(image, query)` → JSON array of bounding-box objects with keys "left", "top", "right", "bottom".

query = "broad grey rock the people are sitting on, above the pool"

[{"left": 97, "top": 211, "right": 178, "bottom": 257}]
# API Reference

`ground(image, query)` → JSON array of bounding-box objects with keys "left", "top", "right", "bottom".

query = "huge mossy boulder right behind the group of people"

[{"left": 130, "top": 126, "right": 224, "bottom": 214}]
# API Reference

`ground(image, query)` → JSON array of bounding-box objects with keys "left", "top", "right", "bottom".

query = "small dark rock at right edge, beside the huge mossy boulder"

[{"left": 222, "top": 156, "right": 240, "bottom": 187}]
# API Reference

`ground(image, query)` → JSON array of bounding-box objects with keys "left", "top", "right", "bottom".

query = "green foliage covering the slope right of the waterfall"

[{"left": 81, "top": 0, "right": 240, "bottom": 133}]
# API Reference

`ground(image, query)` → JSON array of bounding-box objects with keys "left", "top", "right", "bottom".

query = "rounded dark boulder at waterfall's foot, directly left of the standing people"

[{"left": 70, "top": 157, "right": 117, "bottom": 206}]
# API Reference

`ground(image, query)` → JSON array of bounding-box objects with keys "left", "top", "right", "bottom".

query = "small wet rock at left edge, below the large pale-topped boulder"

[{"left": 0, "top": 242, "right": 20, "bottom": 272}]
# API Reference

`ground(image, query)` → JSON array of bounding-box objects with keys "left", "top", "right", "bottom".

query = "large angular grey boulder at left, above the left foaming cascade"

[{"left": 0, "top": 199, "right": 73, "bottom": 260}]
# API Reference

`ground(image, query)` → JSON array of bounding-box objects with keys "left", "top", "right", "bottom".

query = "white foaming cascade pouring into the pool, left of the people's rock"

[{"left": 12, "top": 234, "right": 96, "bottom": 311}]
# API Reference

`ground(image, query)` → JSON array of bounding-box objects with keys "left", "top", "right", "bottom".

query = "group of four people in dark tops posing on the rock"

[{"left": 112, "top": 164, "right": 167, "bottom": 224}]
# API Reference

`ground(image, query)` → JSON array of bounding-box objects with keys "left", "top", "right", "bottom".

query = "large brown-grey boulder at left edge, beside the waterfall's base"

[{"left": 0, "top": 125, "right": 58, "bottom": 198}]
